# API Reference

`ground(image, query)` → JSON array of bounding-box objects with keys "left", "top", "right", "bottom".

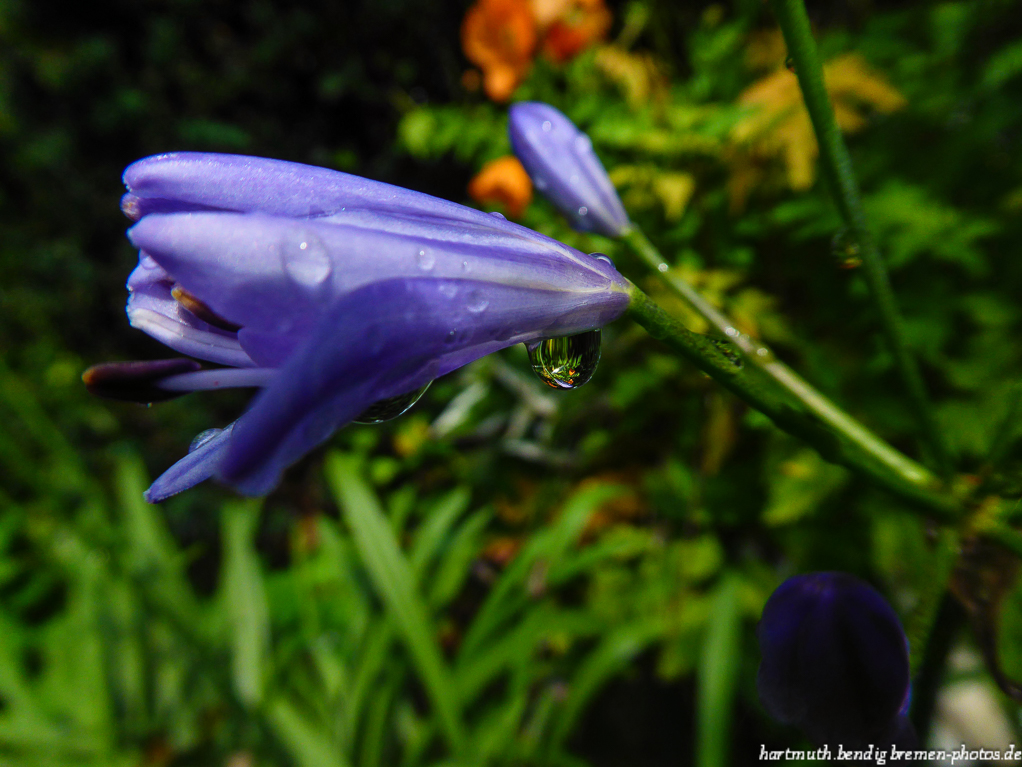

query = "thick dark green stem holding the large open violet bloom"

[{"left": 628, "top": 285, "right": 964, "bottom": 522}]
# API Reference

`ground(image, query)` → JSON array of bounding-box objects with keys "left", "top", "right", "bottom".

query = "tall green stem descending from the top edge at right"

[{"left": 771, "top": 0, "right": 951, "bottom": 477}]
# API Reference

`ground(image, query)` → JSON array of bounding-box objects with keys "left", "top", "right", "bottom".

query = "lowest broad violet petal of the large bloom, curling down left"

[{"left": 219, "top": 277, "right": 628, "bottom": 495}]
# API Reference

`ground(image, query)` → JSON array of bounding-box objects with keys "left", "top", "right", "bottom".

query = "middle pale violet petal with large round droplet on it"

[{"left": 129, "top": 212, "right": 626, "bottom": 343}]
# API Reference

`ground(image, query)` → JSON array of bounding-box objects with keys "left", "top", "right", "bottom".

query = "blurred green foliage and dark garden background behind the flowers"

[{"left": 0, "top": 0, "right": 1022, "bottom": 767}]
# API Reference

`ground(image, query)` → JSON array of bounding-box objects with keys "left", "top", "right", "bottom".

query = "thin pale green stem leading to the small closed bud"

[{"left": 623, "top": 228, "right": 937, "bottom": 505}]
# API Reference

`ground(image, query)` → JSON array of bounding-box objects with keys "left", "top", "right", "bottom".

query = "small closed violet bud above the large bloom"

[{"left": 508, "top": 101, "right": 632, "bottom": 237}]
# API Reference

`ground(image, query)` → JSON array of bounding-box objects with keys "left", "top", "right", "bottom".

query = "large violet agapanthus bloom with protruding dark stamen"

[{"left": 85, "top": 152, "right": 629, "bottom": 502}]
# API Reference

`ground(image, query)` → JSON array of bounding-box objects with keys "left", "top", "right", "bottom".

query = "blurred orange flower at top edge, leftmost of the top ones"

[{"left": 461, "top": 0, "right": 538, "bottom": 101}]
